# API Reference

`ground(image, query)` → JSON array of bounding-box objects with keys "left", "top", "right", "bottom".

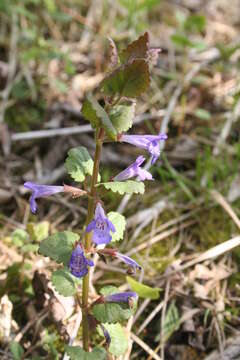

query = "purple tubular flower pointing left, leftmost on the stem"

[{"left": 24, "top": 181, "right": 64, "bottom": 214}]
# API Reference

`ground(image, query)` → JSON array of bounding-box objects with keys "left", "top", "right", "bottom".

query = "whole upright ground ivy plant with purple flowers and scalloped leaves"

[{"left": 24, "top": 32, "right": 166, "bottom": 360}]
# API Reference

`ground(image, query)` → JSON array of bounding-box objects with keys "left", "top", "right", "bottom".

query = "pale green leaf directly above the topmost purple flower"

[{"left": 109, "top": 104, "right": 135, "bottom": 133}]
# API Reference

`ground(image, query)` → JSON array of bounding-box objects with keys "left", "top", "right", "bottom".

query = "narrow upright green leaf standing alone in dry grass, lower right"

[{"left": 163, "top": 301, "right": 180, "bottom": 341}]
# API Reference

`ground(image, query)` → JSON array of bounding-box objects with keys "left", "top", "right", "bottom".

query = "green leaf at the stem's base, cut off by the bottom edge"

[{"left": 65, "top": 345, "right": 107, "bottom": 360}]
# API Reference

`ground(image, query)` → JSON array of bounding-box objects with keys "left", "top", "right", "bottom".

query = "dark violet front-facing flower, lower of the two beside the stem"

[{"left": 69, "top": 244, "right": 94, "bottom": 278}]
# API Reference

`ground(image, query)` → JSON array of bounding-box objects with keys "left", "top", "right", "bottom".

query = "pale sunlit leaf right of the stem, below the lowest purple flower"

[{"left": 98, "top": 323, "right": 128, "bottom": 356}]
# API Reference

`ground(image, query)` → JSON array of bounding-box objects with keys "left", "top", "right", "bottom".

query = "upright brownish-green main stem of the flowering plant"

[{"left": 82, "top": 129, "right": 104, "bottom": 351}]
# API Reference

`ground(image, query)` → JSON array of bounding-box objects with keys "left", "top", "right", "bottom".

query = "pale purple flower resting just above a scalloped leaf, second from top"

[{"left": 113, "top": 156, "right": 153, "bottom": 181}]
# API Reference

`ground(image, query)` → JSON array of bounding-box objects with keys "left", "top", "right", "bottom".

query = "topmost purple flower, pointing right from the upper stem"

[{"left": 119, "top": 134, "right": 167, "bottom": 164}]
